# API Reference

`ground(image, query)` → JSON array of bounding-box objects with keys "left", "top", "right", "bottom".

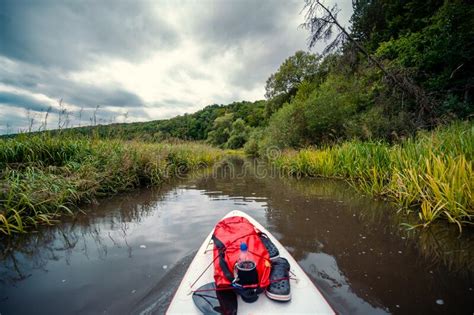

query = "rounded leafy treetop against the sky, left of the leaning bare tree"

[{"left": 265, "top": 50, "right": 321, "bottom": 99}]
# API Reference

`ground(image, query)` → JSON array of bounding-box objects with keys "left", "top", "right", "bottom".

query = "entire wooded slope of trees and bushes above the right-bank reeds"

[{"left": 259, "top": 0, "right": 474, "bottom": 152}]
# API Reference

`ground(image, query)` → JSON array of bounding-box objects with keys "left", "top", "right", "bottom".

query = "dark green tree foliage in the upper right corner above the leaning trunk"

[{"left": 377, "top": 1, "right": 474, "bottom": 118}]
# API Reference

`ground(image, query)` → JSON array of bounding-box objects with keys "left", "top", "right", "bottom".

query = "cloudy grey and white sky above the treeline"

[{"left": 0, "top": 0, "right": 352, "bottom": 134}]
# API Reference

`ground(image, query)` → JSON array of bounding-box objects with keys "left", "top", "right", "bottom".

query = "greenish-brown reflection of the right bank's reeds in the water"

[{"left": 274, "top": 179, "right": 474, "bottom": 277}]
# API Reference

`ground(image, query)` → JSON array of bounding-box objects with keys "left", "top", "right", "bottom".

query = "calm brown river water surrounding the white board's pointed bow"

[{"left": 0, "top": 161, "right": 474, "bottom": 315}]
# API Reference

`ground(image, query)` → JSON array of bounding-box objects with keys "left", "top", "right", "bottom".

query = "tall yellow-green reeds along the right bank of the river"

[{"left": 272, "top": 123, "right": 474, "bottom": 230}]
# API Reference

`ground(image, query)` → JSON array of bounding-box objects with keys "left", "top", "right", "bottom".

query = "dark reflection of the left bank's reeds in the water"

[{"left": 0, "top": 185, "right": 172, "bottom": 283}]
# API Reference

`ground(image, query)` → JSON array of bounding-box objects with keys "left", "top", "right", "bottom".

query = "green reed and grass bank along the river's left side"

[{"left": 0, "top": 134, "right": 224, "bottom": 234}]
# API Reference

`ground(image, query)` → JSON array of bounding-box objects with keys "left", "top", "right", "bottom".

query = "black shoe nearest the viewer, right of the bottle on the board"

[{"left": 265, "top": 257, "right": 291, "bottom": 302}]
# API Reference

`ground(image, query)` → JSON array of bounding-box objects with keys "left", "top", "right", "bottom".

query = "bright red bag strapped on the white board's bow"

[{"left": 212, "top": 216, "right": 271, "bottom": 289}]
